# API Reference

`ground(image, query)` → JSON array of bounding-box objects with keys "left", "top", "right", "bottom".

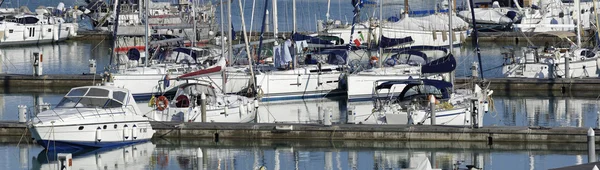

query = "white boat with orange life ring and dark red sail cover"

[{"left": 142, "top": 80, "right": 258, "bottom": 123}]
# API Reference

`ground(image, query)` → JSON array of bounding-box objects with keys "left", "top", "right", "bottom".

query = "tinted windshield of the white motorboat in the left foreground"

[{"left": 56, "top": 88, "right": 127, "bottom": 108}]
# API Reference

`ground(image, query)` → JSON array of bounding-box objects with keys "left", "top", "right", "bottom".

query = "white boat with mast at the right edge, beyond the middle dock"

[{"left": 502, "top": 1, "right": 600, "bottom": 79}]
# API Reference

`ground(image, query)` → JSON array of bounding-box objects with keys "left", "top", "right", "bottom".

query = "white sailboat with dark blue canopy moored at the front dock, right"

[{"left": 365, "top": 79, "right": 491, "bottom": 126}]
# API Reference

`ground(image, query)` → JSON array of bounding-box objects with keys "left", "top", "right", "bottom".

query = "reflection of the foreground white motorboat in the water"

[{"left": 32, "top": 142, "right": 155, "bottom": 170}]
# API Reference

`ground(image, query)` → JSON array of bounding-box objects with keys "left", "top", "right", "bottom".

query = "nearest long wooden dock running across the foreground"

[{"left": 0, "top": 121, "right": 600, "bottom": 145}]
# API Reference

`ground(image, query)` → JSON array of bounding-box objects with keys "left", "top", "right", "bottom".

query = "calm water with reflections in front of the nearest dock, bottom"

[{"left": 0, "top": 138, "right": 587, "bottom": 170}]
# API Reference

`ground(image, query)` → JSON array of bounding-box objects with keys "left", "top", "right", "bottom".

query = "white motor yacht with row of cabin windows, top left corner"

[{"left": 0, "top": 9, "right": 79, "bottom": 46}]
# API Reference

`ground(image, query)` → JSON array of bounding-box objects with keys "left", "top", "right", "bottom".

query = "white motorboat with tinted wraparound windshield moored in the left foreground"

[{"left": 28, "top": 85, "right": 154, "bottom": 150}]
